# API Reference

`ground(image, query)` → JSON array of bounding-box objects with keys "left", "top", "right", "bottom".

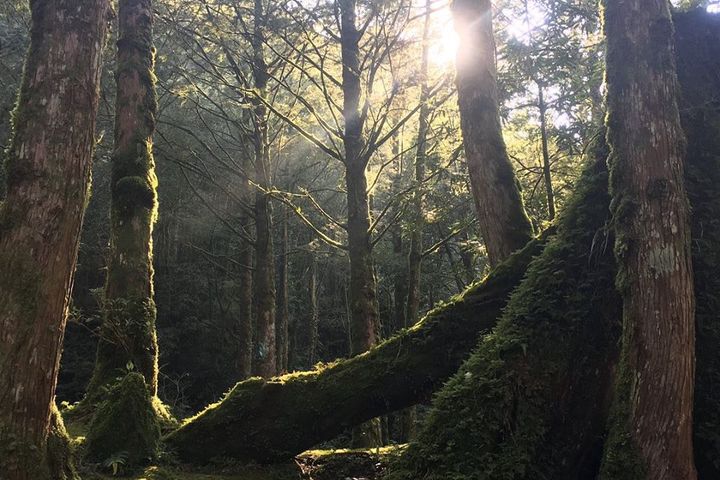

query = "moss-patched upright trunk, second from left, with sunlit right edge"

[{"left": 87, "top": 0, "right": 158, "bottom": 403}]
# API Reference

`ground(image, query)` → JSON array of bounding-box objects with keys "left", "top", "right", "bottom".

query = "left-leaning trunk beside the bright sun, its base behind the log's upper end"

[{"left": 453, "top": 0, "right": 532, "bottom": 266}]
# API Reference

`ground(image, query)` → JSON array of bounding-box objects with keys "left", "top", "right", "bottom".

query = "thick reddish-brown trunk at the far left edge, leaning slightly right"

[{"left": 0, "top": 0, "right": 109, "bottom": 480}]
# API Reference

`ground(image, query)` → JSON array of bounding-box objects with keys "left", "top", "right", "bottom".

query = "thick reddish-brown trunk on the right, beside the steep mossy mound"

[{"left": 602, "top": 0, "right": 696, "bottom": 480}]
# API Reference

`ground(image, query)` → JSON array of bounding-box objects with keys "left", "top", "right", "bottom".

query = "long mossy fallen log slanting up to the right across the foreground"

[{"left": 166, "top": 234, "right": 544, "bottom": 463}]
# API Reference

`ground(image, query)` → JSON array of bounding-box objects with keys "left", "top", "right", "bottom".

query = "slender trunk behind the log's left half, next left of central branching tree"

[{"left": 252, "top": 0, "right": 277, "bottom": 378}]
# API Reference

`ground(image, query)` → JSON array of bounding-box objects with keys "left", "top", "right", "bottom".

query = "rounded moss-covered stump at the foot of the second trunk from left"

[{"left": 85, "top": 372, "right": 160, "bottom": 471}]
